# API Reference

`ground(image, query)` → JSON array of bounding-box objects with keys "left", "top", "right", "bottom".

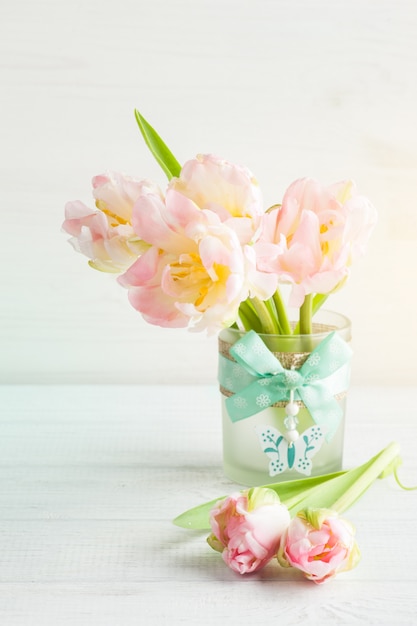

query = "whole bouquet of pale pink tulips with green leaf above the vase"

[{"left": 63, "top": 111, "right": 376, "bottom": 335}]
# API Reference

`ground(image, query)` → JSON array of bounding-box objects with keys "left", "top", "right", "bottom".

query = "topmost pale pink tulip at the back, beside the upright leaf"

[{"left": 170, "top": 154, "right": 264, "bottom": 243}]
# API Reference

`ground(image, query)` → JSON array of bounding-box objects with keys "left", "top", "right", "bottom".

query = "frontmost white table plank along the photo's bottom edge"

[{"left": 0, "top": 571, "right": 417, "bottom": 626}]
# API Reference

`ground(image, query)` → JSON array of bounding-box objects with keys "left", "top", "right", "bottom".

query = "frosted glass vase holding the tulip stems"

[{"left": 219, "top": 311, "right": 351, "bottom": 486}]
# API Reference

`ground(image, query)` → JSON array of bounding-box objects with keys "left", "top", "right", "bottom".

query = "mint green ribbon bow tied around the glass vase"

[{"left": 219, "top": 331, "right": 352, "bottom": 441}]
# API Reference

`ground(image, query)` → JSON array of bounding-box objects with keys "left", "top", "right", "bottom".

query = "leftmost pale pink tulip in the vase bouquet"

[{"left": 63, "top": 173, "right": 160, "bottom": 273}]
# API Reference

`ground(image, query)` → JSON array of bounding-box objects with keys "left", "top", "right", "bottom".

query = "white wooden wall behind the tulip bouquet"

[{"left": 0, "top": 0, "right": 417, "bottom": 384}]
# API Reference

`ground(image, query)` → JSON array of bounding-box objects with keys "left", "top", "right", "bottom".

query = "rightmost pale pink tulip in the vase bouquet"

[{"left": 255, "top": 178, "right": 376, "bottom": 307}]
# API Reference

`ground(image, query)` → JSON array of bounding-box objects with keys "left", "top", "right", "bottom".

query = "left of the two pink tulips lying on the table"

[{"left": 208, "top": 487, "right": 290, "bottom": 574}]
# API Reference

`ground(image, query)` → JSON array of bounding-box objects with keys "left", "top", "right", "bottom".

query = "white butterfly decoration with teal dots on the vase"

[{"left": 257, "top": 425, "right": 324, "bottom": 476}]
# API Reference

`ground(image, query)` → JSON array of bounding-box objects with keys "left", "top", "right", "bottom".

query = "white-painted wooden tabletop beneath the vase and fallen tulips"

[{"left": 0, "top": 386, "right": 417, "bottom": 626}]
